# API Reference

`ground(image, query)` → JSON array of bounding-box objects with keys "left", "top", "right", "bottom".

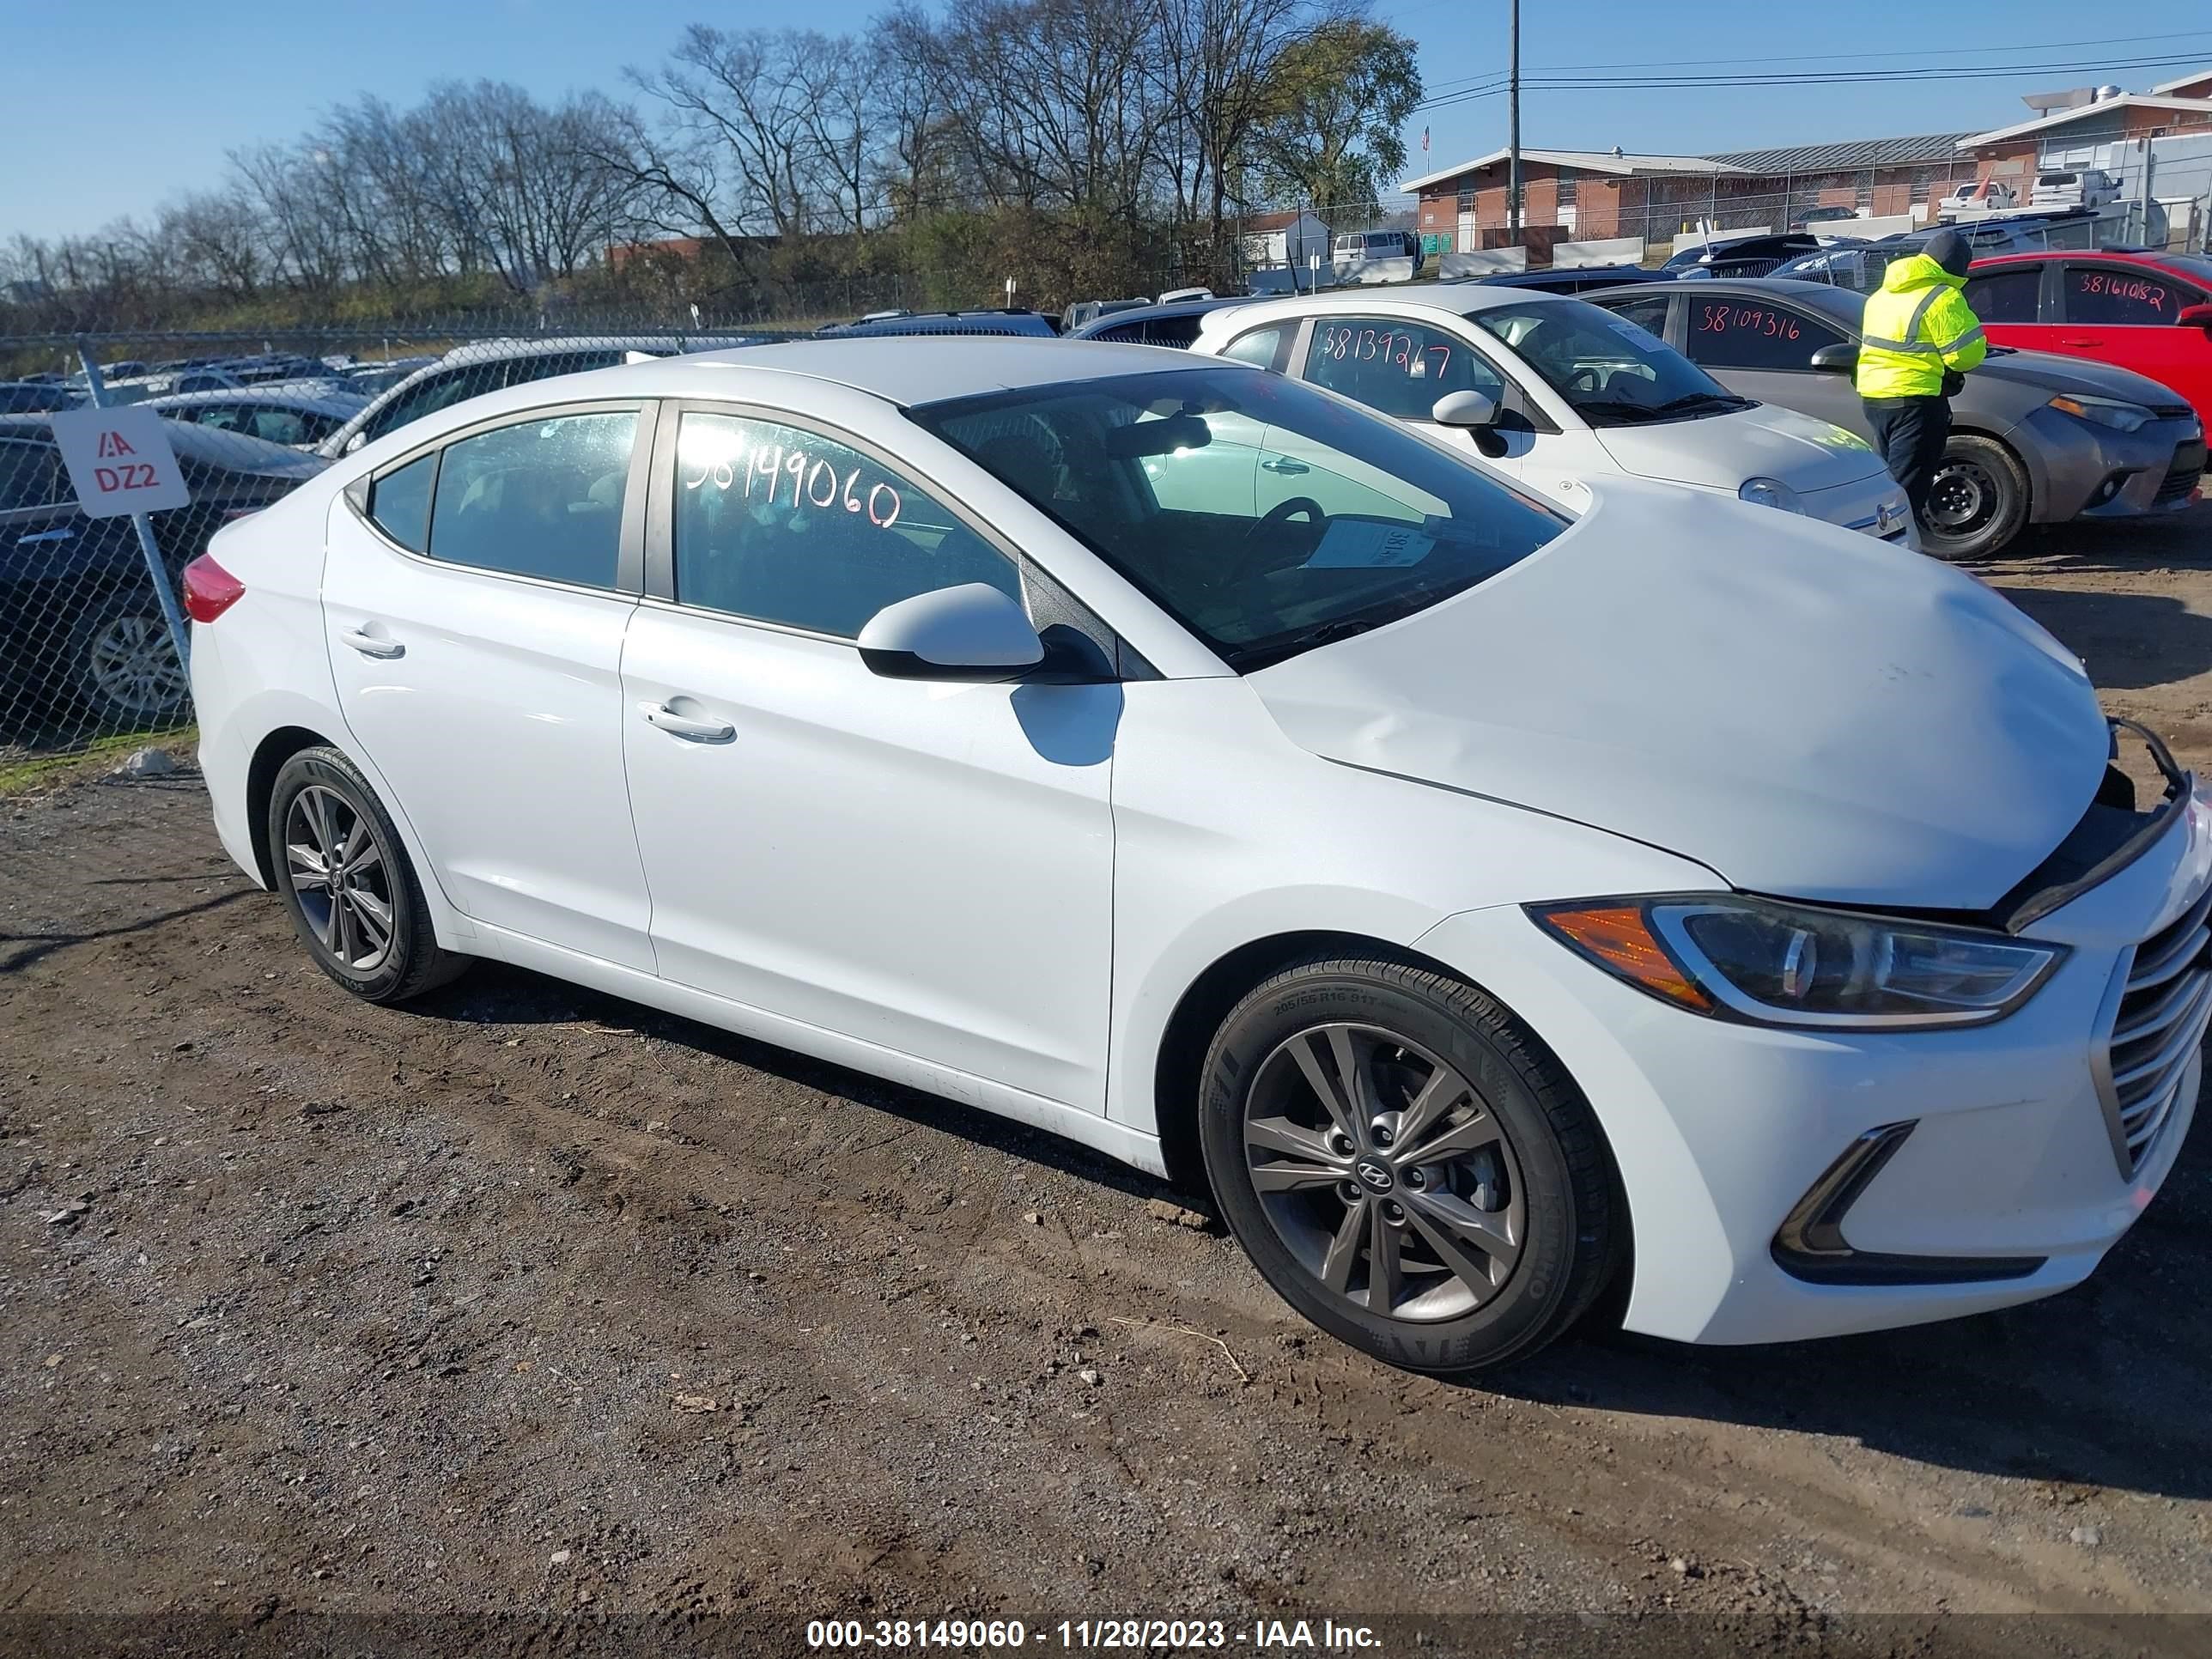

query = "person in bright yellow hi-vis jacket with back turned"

[{"left": 1856, "top": 230, "right": 1989, "bottom": 518}]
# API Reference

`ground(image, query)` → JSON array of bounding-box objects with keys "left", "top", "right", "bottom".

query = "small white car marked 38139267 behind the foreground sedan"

[{"left": 1190, "top": 283, "right": 1913, "bottom": 544}]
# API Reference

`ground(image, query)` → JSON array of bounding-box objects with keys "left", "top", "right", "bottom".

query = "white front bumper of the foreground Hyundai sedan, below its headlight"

[{"left": 1420, "top": 787, "right": 2212, "bottom": 1343}]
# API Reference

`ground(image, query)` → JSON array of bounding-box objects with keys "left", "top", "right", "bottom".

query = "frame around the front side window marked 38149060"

[{"left": 630, "top": 398, "right": 1152, "bottom": 679}]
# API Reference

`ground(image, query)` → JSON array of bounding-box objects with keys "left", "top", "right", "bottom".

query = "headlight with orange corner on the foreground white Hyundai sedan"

[{"left": 1528, "top": 894, "right": 2066, "bottom": 1030}]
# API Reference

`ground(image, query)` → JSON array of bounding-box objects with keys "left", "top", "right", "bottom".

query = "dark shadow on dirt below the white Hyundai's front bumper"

[{"left": 1475, "top": 1133, "right": 2212, "bottom": 1498}]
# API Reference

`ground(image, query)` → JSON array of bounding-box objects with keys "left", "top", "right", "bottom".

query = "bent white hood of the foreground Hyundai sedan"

[{"left": 1249, "top": 477, "right": 2111, "bottom": 909}]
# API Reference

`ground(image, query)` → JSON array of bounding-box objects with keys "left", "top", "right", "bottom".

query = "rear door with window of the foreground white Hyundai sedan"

[{"left": 323, "top": 400, "right": 653, "bottom": 971}]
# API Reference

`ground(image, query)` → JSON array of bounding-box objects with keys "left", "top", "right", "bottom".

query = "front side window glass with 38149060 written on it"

[{"left": 672, "top": 414, "right": 1017, "bottom": 639}]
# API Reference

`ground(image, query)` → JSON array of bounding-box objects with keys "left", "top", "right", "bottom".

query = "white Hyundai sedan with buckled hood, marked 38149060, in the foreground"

[{"left": 185, "top": 338, "right": 2212, "bottom": 1371}]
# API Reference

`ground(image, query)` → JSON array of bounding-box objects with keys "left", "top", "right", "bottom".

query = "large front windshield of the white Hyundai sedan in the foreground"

[{"left": 909, "top": 365, "right": 1568, "bottom": 672}]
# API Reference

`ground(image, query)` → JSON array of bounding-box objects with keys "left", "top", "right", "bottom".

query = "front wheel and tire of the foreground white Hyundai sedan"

[{"left": 1199, "top": 957, "right": 1628, "bottom": 1374}]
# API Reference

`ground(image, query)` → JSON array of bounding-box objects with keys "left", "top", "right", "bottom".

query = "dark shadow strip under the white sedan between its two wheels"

[{"left": 392, "top": 963, "right": 1212, "bottom": 1217}]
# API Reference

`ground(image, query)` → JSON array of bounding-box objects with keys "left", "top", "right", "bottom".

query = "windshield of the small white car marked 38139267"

[{"left": 1468, "top": 299, "right": 1752, "bottom": 427}]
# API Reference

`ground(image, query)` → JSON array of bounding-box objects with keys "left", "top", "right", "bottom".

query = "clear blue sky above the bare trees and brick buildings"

[{"left": 13, "top": 0, "right": 2212, "bottom": 239}]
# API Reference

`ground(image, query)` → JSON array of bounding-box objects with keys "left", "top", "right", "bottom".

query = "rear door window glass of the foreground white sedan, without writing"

[{"left": 422, "top": 411, "right": 637, "bottom": 588}]
